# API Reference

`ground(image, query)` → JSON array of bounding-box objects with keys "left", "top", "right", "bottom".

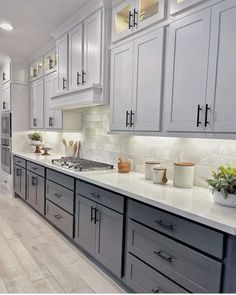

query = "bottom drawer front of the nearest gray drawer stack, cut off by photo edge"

[{"left": 126, "top": 254, "right": 188, "bottom": 293}]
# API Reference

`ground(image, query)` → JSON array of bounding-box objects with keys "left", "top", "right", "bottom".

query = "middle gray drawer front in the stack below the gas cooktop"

[{"left": 46, "top": 180, "right": 74, "bottom": 214}]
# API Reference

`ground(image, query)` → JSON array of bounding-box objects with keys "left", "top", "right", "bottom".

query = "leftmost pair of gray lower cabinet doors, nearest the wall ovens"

[{"left": 14, "top": 165, "right": 26, "bottom": 200}]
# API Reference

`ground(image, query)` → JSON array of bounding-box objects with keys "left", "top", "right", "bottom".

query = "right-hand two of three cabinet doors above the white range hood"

[{"left": 69, "top": 10, "right": 102, "bottom": 90}]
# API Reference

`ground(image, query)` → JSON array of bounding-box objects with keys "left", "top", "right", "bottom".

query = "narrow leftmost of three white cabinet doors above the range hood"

[{"left": 56, "top": 34, "right": 68, "bottom": 93}]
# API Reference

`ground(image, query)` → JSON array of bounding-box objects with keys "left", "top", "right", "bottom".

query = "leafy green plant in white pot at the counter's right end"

[{"left": 207, "top": 166, "right": 236, "bottom": 207}]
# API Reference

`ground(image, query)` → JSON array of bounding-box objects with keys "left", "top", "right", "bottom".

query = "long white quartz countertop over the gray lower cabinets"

[{"left": 14, "top": 152, "right": 236, "bottom": 235}]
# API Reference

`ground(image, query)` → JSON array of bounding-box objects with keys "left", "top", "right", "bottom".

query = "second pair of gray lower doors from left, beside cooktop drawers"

[{"left": 26, "top": 171, "right": 45, "bottom": 215}]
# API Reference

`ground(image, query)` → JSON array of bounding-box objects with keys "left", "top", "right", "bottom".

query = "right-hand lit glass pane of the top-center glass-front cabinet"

[{"left": 139, "top": 0, "right": 159, "bottom": 22}]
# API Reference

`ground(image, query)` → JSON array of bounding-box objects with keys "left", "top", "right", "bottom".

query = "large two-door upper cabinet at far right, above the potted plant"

[{"left": 166, "top": 0, "right": 236, "bottom": 133}]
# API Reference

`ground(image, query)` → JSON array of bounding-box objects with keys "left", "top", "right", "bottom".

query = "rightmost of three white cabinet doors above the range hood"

[{"left": 82, "top": 10, "right": 102, "bottom": 87}]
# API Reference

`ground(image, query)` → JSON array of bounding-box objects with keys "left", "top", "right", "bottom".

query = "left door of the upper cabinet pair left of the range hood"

[{"left": 30, "top": 78, "right": 44, "bottom": 129}]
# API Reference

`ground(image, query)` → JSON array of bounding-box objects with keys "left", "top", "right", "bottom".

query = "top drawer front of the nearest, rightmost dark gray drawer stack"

[{"left": 128, "top": 200, "right": 224, "bottom": 259}]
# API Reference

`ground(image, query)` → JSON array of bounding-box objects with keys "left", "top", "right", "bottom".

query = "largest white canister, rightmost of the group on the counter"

[{"left": 173, "top": 162, "right": 195, "bottom": 188}]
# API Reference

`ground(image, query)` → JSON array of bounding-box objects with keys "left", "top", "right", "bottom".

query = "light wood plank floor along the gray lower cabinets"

[{"left": 0, "top": 187, "right": 125, "bottom": 293}]
